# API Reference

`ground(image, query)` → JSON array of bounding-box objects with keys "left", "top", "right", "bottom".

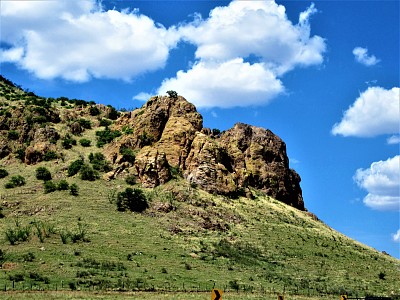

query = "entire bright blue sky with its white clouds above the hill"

[{"left": 0, "top": 0, "right": 400, "bottom": 258}]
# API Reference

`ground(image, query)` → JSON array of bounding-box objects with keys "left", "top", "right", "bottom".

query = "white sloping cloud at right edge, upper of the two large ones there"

[{"left": 332, "top": 87, "right": 400, "bottom": 137}]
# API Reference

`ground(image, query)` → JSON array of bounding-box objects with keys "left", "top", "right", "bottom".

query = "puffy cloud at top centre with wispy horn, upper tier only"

[{"left": 179, "top": 1, "right": 326, "bottom": 75}]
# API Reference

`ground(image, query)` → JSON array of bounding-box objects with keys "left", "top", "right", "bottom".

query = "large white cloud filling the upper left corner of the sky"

[{"left": 1, "top": 1, "right": 179, "bottom": 81}]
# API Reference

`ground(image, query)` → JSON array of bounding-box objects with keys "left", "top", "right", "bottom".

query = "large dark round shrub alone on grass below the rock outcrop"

[{"left": 116, "top": 188, "right": 149, "bottom": 212}]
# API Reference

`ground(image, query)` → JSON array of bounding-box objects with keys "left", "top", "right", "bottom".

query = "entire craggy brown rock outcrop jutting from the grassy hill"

[{"left": 105, "top": 96, "right": 304, "bottom": 210}]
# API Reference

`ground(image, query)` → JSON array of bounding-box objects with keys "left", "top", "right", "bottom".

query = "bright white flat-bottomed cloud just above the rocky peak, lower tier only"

[{"left": 158, "top": 58, "right": 284, "bottom": 108}]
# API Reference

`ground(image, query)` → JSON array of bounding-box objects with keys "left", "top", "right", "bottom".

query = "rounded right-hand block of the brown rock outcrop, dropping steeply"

[{"left": 220, "top": 123, "right": 304, "bottom": 209}]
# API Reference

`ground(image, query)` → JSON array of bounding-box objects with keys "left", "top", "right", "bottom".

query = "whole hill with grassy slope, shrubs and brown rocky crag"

[{"left": 0, "top": 78, "right": 400, "bottom": 299}]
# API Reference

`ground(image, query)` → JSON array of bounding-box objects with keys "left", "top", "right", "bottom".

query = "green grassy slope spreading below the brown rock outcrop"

[{"left": 0, "top": 76, "right": 400, "bottom": 299}]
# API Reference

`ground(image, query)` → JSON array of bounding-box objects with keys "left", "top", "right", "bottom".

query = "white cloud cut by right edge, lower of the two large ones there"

[{"left": 353, "top": 155, "right": 400, "bottom": 210}]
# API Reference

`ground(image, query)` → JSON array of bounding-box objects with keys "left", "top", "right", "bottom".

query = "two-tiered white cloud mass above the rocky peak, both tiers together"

[{"left": 152, "top": 1, "right": 326, "bottom": 107}]
